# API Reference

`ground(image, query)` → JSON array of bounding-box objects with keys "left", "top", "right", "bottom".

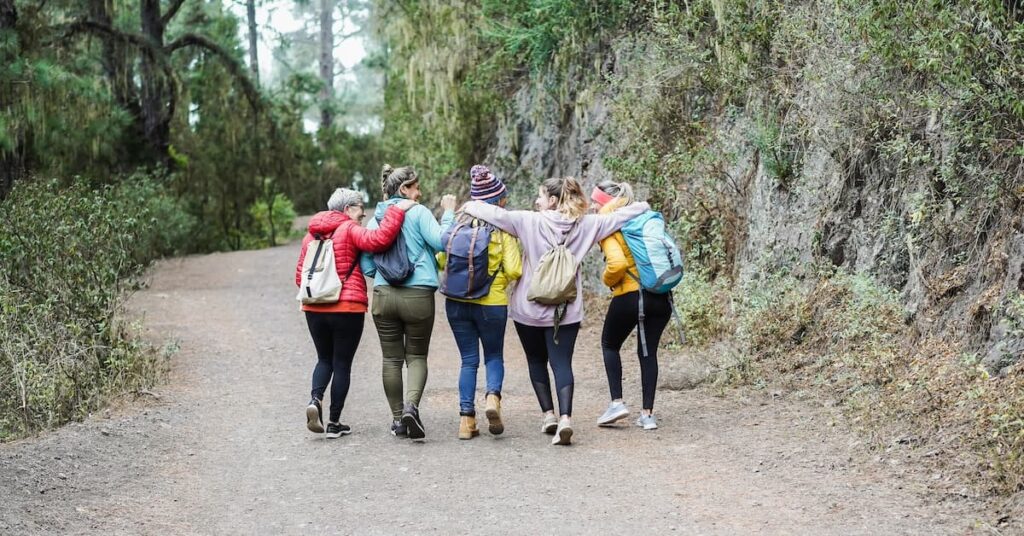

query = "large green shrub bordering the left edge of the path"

[{"left": 0, "top": 175, "right": 194, "bottom": 439}]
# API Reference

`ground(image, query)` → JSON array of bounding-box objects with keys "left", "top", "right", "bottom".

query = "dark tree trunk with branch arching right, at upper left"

[{"left": 139, "top": 0, "right": 171, "bottom": 164}]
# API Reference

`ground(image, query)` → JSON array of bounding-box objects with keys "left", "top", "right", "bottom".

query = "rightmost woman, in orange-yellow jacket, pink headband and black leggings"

[{"left": 591, "top": 180, "right": 672, "bottom": 429}]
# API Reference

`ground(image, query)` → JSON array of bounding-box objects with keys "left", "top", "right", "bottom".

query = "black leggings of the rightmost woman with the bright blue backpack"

[{"left": 601, "top": 291, "right": 672, "bottom": 410}]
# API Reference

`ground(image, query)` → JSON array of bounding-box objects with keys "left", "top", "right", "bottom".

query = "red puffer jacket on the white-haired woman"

[{"left": 295, "top": 207, "right": 406, "bottom": 311}]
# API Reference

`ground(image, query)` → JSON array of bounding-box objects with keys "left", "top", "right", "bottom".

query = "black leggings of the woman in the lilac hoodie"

[{"left": 515, "top": 322, "right": 580, "bottom": 415}]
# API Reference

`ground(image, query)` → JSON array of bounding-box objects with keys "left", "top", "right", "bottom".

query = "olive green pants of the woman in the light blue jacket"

[{"left": 371, "top": 285, "right": 434, "bottom": 420}]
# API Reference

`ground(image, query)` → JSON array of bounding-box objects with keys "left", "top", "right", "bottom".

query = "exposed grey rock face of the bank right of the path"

[{"left": 488, "top": 31, "right": 1024, "bottom": 373}]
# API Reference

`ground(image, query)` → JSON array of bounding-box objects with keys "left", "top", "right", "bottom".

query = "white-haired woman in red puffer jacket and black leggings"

[{"left": 295, "top": 188, "right": 416, "bottom": 438}]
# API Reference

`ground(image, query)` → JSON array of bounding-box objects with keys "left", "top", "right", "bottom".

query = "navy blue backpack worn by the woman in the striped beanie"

[{"left": 440, "top": 219, "right": 501, "bottom": 299}]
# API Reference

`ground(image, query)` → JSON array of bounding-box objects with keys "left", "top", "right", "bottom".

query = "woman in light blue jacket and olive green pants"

[{"left": 362, "top": 165, "right": 456, "bottom": 440}]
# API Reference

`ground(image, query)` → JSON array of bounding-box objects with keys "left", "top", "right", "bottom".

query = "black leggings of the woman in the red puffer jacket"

[{"left": 306, "top": 312, "right": 366, "bottom": 422}]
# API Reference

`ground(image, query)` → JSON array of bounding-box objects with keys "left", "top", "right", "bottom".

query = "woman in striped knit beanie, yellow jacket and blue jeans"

[{"left": 438, "top": 165, "right": 522, "bottom": 440}]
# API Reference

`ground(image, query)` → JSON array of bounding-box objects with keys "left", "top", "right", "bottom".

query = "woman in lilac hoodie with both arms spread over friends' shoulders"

[{"left": 463, "top": 177, "right": 650, "bottom": 445}]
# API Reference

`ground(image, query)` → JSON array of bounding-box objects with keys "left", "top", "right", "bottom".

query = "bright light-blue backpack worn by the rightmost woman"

[{"left": 622, "top": 210, "right": 683, "bottom": 294}]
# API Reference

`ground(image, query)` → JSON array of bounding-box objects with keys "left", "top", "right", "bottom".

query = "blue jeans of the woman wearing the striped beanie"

[{"left": 444, "top": 299, "right": 509, "bottom": 415}]
